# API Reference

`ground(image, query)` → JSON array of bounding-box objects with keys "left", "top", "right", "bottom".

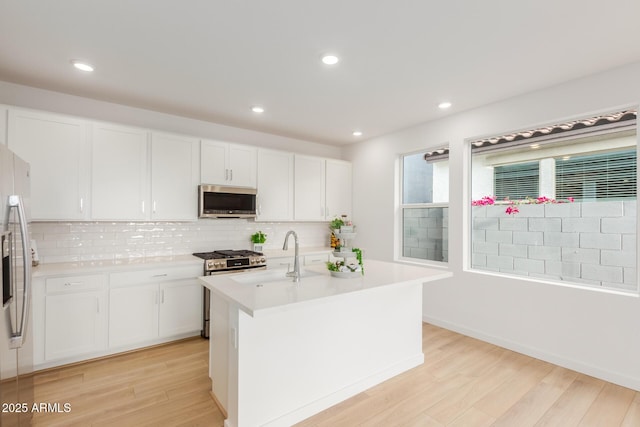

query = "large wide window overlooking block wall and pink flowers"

[{"left": 469, "top": 110, "right": 638, "bottom": 292}]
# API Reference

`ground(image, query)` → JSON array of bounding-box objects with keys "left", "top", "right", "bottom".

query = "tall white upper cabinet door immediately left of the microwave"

[{"left": 151, "top": 133, "right": 200, "bottom": 221}]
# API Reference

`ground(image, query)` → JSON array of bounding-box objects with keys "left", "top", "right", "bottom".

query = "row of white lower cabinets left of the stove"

[{"left": 32, "top": 263, "right": 203, "bottom": 370}]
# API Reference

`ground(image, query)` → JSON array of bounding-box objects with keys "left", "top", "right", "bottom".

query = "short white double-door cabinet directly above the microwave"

[{"left": 200, "top": 140, "right": 257, "bottom": 188}]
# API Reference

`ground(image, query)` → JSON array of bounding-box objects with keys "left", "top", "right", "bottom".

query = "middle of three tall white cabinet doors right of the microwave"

[{"left": 294, "top": 154, "right": 327, "bottom": 221}]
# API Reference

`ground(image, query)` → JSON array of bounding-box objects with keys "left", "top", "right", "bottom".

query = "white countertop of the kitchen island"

[{"left": 199, "top": 260, "right": 452, "bottom": 317}]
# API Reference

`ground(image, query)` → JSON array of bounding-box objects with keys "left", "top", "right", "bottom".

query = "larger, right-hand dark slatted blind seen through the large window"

[{"left": 556, "top": 150, "right": 637, "bottom": 201}]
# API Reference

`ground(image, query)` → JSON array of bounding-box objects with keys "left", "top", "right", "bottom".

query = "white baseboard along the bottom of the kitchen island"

[{"left": 260, "top": 353, "right": 424, "bottom": 427}]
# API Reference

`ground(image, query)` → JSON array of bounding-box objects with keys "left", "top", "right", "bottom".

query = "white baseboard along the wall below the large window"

[{"left": 422, "top": 316, "right": 640, "bottom": 391}]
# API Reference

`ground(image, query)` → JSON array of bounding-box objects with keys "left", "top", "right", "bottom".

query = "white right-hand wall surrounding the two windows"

[{"left": 345, "top": 63, "right": 640, "bottom": 390}]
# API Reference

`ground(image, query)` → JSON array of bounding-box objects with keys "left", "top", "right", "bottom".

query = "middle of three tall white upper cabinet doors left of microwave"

[{"left": 91, "top": 123, "right": 150, "bottom": 221}]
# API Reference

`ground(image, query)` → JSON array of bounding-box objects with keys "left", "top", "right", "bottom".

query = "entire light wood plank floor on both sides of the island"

[{"left": 34, "top": 324, "right": 640, "bottom": 427}]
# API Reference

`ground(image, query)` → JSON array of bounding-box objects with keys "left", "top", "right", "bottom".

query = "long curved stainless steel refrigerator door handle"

[{"left": 5, "top": 195, "right": 31, "bottom": 348}]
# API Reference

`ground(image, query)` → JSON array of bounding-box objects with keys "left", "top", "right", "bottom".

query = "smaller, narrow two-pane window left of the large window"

[{"left": 400, "top": 148, "right": 449, "bottom": 262}]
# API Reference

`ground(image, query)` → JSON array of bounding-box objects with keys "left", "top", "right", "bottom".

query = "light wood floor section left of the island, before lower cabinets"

[{"left": 33, "top": 337, "right": 224, "bottom": 427}]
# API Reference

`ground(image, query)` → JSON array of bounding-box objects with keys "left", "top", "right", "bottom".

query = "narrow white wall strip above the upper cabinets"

[{"left": 0, "top": 81, "right": 341, "bottom": 159}]
